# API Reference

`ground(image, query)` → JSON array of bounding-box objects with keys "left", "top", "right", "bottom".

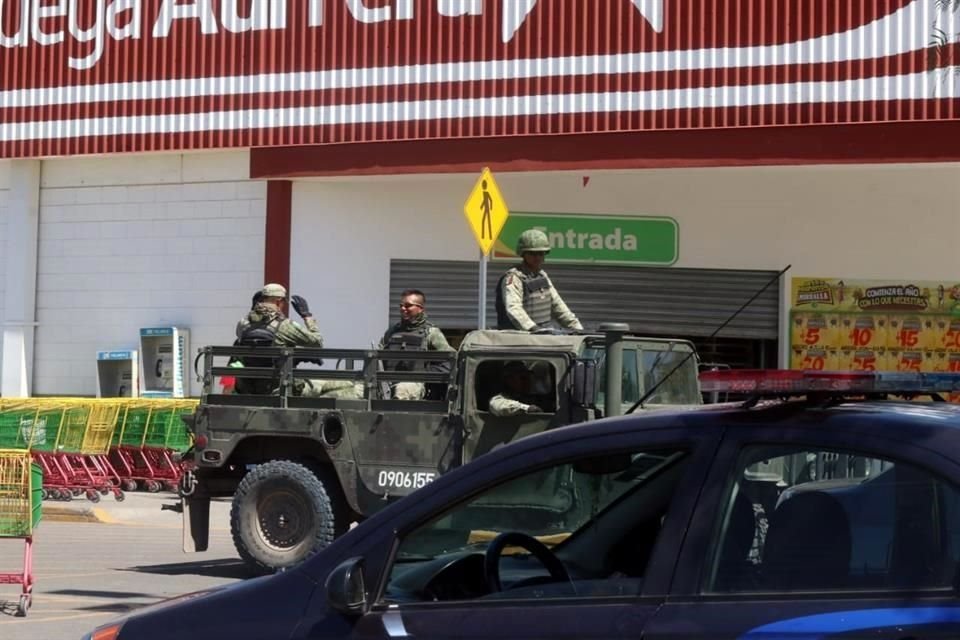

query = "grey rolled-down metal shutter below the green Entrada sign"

[{"left": 390, "top": 260, "right": 781, "bottom": 340}]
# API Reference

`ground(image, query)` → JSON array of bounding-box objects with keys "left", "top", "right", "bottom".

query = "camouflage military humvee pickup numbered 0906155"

[{"left": 180, "top": 324, "right": 701, "bottom": 573}]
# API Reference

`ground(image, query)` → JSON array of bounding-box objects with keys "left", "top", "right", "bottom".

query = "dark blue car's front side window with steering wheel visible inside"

[{"left": 384, "top": 449, "right": 687, "bottom": 603}]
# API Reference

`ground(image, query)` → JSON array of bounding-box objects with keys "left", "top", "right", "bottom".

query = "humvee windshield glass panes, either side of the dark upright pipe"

[{"left": 583, "top": 342, "right": 701, "bottom": 407}]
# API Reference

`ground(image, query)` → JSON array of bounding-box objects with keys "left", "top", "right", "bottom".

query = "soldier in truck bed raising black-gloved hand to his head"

[{"left": 236, "top": 283, "right": 323, "bottom": 394}]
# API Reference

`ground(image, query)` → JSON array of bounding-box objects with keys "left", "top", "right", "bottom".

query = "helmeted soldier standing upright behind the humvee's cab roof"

[{"left": 496, "top": 229, "right": 583, "bottom": 331}]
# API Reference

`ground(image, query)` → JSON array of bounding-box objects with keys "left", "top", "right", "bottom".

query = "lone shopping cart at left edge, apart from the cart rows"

[{"left": 0, "top": 449, "right": 43, "bottom": 616}]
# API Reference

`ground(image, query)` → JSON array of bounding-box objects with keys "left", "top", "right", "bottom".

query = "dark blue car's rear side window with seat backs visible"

[{"left": 704, "top": 446, "right": 960, "bottom": 593}]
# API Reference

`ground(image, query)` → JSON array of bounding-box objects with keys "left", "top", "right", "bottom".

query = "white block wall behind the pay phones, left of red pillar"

[{"left": 33, "top": 152, "right": 266, "bottom": 395}]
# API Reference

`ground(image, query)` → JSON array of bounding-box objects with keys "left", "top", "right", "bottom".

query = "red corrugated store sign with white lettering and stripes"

[{"left": 0, "top": 0, "right": 960, "bottom": 157}]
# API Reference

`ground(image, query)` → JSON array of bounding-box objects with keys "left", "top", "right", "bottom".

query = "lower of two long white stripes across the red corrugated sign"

[{"left": 0, "top": 72, "right": 960, "bottom": 141}]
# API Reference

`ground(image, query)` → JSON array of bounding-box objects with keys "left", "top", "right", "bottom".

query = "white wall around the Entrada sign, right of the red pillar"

[{"left": 291, "top": 164, "right": 960, "bottom": 347}]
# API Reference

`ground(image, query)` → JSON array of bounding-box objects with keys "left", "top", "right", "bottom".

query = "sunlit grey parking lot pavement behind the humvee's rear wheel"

[{"left": 0, "top": 493, "right": 249, "bottom": 640}]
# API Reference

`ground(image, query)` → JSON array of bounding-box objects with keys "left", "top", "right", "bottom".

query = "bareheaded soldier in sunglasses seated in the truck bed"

[{"left": 377, "top": 289, "right": 454, "bottom": 400}]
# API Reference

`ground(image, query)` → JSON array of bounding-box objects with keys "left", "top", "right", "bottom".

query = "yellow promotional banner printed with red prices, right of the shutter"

[{"left": 790, "top": 278, "right": 960, "bottom": 380}]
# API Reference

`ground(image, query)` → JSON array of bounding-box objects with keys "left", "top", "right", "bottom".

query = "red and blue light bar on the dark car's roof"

[{"left": 700, "top": 369, "right": 960, "bottom": 396}]
